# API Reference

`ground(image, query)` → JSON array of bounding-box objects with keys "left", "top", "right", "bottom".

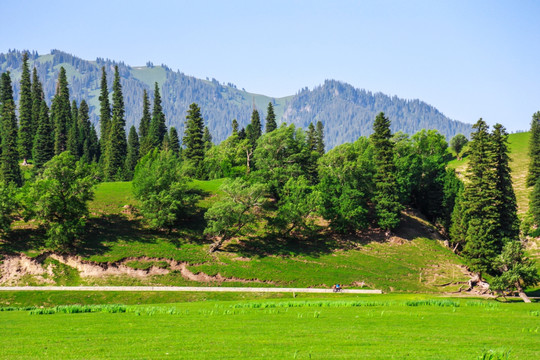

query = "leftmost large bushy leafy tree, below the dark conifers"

[{"left": 25, "top": 152, "right": 95, "bottom": 250}]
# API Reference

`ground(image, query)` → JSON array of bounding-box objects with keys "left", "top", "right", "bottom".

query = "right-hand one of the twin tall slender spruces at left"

[{"left": 105, "top": 66, "right": 127, "bottom": 180}]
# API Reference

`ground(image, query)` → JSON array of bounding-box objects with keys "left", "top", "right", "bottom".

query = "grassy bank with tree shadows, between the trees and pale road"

[{"left": 2, "top": 180, "right": 465, "bottom": 292}]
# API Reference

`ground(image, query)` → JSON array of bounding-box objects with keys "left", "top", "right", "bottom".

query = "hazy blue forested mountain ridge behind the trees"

[{"left": 0, "top": 50, "right": 471, "bottom": 149}]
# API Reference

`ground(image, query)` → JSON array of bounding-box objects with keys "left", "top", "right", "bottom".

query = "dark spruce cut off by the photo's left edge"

[{"left": 0, "top": 72, "right": 22, "bottom": 186}]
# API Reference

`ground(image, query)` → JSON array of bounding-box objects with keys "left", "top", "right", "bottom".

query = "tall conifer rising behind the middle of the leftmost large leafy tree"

[{"left": 51, "top": 67, "right": 71, "bottom": 155}]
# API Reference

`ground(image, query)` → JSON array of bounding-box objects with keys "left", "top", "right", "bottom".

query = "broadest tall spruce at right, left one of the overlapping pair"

[{"left": 462, "top": 119, "right": 503, "bottom": 276}]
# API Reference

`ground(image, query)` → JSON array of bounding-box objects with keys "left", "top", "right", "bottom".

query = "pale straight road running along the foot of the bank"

[{"left": 0, "top": 286, "right": 382, "bottom": 294}]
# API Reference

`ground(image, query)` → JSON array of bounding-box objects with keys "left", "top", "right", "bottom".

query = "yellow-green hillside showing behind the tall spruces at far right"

[{"left": 448, "top": 132, "right": 531, "bottom": 215}]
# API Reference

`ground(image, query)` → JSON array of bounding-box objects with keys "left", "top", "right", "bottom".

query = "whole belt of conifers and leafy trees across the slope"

[{"left": 0, "top": 52, "right": 540, "bottom": 295}]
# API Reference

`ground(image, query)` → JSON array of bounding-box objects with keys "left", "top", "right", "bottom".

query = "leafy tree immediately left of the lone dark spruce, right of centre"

[{"left": 317, "top": 138, "right": 375, "bottom": 232}]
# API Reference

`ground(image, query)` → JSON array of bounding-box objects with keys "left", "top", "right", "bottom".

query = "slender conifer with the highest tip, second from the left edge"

[{"left": 18, "top": 52, "right": 35, "bottom": 162}]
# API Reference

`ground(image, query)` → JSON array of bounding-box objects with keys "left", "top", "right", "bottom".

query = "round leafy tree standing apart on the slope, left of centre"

[{"left": 133, "top": 149, "right": 198, "bottom": 230}]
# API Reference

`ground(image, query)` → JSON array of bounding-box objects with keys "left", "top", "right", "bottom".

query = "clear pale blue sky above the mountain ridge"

[{"left": 0, "top": 0, "right": 540, "bottom": 131}]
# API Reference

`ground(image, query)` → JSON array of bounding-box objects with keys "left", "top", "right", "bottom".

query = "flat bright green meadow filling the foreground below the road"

[{"left": 0, "top": 295, "right": 540, "bottom": 359}]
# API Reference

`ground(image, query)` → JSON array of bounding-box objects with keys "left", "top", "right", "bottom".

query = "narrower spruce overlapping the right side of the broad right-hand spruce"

[{"left": 491, "top": 124, "right": 519, "bottom": 243}]
